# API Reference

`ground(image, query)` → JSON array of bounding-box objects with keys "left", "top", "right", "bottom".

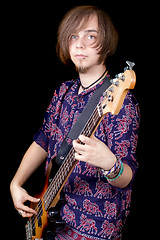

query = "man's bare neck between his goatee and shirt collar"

[{"left": 79, "top": 65, "right": 106, "bottom": 90}]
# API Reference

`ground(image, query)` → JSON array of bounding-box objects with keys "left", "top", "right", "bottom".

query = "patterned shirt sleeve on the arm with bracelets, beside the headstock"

[{"left": 102, "top": 92, "right": 140, "bottom": 179}]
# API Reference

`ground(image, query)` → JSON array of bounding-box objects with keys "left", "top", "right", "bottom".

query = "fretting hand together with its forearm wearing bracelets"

[{"left": 73, "top": 135, "right": 132, "bottom": 188}]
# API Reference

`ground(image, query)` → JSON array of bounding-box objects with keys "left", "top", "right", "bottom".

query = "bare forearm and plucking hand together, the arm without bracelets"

[{"left": 10, "top": 142, "right": 47, "bottom": 217}]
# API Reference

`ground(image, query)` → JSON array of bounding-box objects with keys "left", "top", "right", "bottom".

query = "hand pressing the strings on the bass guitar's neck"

[{"left": 73, "top": 135, "right": 116, "bottom": 170}]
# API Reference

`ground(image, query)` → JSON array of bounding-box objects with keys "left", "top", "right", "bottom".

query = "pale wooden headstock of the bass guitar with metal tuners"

[{"left": 101, "top": 70, "right": 136, "bottom": 115}]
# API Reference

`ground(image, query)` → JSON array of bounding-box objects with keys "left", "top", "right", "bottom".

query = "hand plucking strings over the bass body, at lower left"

[{"left": 11, "top": 184, "right": 40, "bottom": 217}]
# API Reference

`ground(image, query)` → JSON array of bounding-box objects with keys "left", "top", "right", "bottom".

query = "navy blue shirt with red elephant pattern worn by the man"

[{"left": 34, "top": 79, "right": 140, "bottom": 239}]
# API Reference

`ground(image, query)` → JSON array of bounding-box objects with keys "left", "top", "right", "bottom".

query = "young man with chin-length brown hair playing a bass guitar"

[{"left": 11, "top": 6, "right": 139, "bottom": 239}]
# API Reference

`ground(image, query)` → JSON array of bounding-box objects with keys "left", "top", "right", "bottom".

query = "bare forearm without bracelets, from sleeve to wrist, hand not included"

[{"left": 11, "top": 142, "right": 47, "bottom": 187}]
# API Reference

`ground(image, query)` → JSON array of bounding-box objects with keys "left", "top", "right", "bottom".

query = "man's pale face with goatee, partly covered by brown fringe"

[{"left": 69, "top": 16, "right": 99, "bottom": 73}]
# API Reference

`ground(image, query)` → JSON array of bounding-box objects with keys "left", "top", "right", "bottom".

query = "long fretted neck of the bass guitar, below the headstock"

[{"left": 43, "top": 103, "right": 103, "bottom": 211}]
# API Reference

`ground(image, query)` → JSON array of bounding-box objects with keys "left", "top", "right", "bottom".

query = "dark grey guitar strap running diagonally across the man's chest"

[{"left": 55, "top": 77, "right": 111, "bottom": 165}]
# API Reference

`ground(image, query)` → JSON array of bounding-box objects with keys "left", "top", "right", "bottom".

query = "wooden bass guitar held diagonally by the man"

[{"left": 25, "top": 61, "right": 136, "bottom": 240}]
